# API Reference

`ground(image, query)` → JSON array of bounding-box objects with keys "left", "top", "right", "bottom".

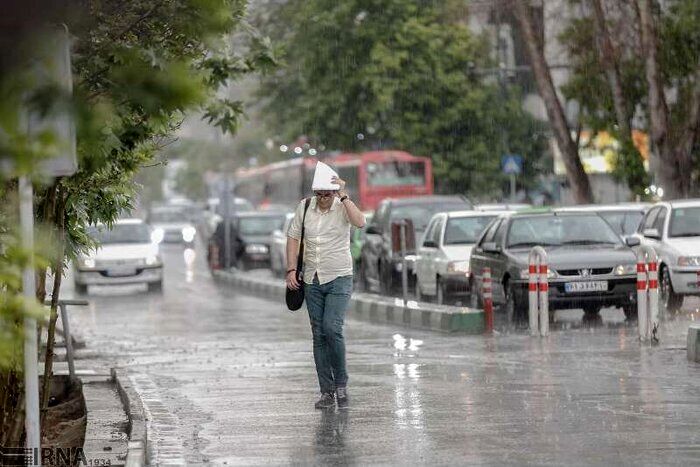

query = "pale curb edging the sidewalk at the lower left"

[{"left": 111, "top": 368, "right": 148, "bottom": 467}]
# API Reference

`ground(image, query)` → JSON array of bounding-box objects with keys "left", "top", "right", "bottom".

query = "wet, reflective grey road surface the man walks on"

[{"left": 65, "top": 246, "right": 700, "bottom": 465}]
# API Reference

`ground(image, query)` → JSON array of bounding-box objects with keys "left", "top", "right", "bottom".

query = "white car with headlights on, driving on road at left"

[{"left": 74, "top": 219, "right": 163, "bottom": 293}]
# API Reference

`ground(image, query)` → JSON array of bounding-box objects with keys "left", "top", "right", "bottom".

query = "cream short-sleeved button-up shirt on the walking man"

[{"left": 287, "top": 196, "right": 352, "bottom": 284}]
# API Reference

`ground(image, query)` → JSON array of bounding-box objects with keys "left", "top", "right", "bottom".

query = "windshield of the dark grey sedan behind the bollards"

[{"left": 507, "top": 214, "right": 621, "bottom": 248}]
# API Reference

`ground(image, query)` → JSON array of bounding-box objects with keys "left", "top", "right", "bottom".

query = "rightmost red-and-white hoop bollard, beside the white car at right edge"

[{"left": 637, "top": 245, "right": 659, "bottom": 342}]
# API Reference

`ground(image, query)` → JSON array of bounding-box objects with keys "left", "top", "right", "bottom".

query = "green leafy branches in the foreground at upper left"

[{"left": 0, "top": 0, "right": 275, "bottom": 376}]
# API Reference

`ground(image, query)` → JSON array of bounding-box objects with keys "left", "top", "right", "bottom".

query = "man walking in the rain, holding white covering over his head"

[{"left": 286, "top": 162, "right": 365, "bottom": 409}]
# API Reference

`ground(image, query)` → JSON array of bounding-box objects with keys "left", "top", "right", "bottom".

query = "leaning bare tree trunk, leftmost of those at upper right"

[{"left": 511, "top": 0, "right": 593, "bottom": 204}]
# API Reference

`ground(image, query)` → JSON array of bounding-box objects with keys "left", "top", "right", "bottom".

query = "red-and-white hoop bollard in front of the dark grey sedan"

[{"left": 527, "top": 246, "right": 549, "bottom": 337}]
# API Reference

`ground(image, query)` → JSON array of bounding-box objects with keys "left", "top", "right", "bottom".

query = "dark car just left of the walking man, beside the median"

[{"left": 213, "top": 211, "right": 286, "bottom": 270}]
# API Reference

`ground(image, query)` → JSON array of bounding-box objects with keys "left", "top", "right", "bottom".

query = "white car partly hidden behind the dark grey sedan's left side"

[{"left": 416, "top": 211, "right": 505, "bottom": 304}]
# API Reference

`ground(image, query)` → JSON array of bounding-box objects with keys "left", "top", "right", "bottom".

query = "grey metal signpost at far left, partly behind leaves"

[{"left": 19, "top": 177, "right": 41, "bottom": 452}]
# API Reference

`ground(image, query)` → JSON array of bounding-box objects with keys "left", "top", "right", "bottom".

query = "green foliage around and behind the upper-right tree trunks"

[{"left": 560, "top": 0, "right": 700, "bottom": 195}]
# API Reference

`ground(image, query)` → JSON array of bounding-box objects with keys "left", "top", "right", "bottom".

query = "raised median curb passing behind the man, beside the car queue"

[{"left": 212, "top": 270, "right": 486, "bottom": 334}]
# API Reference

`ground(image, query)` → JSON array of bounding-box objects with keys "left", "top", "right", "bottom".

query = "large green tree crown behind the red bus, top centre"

[{"left": 260, "top": 0, "right": 545, "bottom": 198}]
